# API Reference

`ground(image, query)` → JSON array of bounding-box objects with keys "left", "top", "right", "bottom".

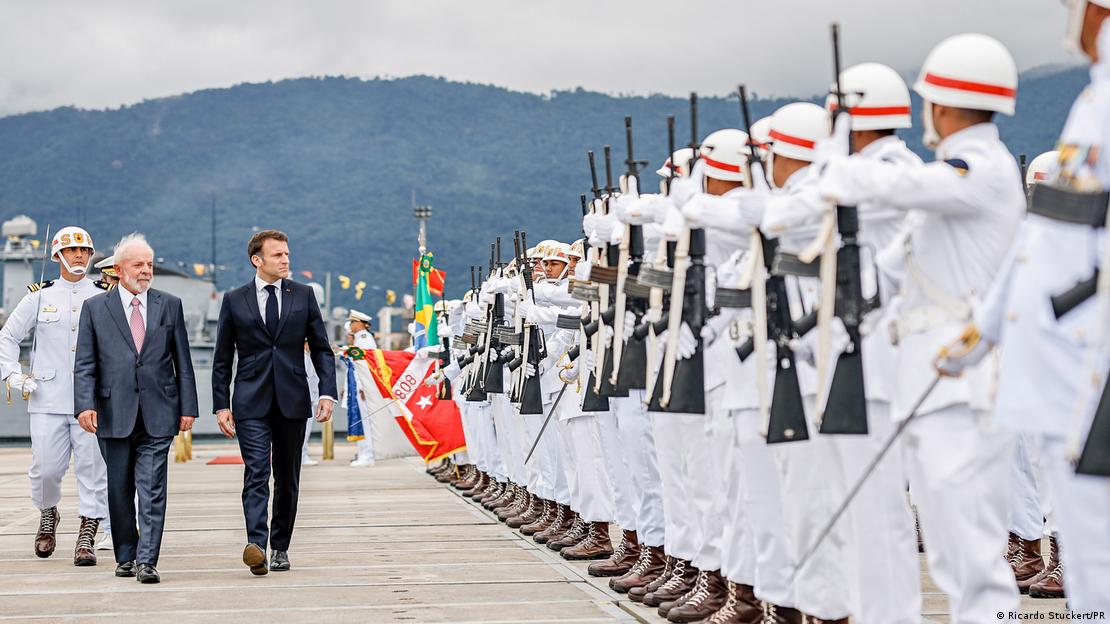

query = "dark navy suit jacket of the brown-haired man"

[{"left": 212, "top": 279, "right": 336, "bottom": 421}]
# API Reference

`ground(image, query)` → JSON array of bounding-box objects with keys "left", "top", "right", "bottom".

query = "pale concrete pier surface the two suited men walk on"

[{"left": 0, "top": 443, "right": 1066, "bottom": 624}]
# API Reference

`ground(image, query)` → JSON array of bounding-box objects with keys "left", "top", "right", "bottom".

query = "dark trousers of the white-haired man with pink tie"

[{"left": 99, "top": 412, "right": 173, "bottom": 565}]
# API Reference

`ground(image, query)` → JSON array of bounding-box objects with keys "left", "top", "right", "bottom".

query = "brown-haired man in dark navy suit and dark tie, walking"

[{"left": 212, "top": 230, "right": 336, "bottom": 575}]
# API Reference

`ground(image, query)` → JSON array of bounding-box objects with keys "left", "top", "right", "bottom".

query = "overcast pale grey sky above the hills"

[{"left": 0, "top": 0, "right": 1076, "bottom": 114}]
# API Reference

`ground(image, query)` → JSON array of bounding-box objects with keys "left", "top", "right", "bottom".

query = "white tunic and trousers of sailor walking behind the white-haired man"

[{"left": 0, "top": 279, "right": 108, "bottom": 519}]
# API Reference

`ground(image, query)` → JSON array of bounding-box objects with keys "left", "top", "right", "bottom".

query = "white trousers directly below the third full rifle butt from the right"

[{"left": 649, "top": 412, "right": 705, "bottom": 561}]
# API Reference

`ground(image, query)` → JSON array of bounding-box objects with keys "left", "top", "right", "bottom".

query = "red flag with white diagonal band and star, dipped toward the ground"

[{"left": 366, "top": 350, "right": 466, "bottom": 462}]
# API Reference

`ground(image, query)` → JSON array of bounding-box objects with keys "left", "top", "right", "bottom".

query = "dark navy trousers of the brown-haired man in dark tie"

[{"left": 235, "top": 399, "right": 304, "bottom": 552}]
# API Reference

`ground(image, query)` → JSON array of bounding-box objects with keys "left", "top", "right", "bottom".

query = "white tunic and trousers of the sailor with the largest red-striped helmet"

[{"left": 819, "top": 123, "right": 1025, "bottom": 622}]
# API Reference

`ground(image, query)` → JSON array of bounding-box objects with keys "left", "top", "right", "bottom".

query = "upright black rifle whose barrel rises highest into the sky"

[{"left": 818, "top": 23, "right": 868, "bottom": 435}]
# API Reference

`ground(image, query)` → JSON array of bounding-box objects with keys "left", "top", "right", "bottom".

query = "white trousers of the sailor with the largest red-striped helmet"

[{"left": 902, "top": 403, "right": 1018, "bottom": 624}]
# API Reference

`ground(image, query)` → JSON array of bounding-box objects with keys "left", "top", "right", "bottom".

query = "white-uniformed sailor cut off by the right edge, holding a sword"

[{"left": 940, "top": 0, "right": 1110, "bottom": 614}]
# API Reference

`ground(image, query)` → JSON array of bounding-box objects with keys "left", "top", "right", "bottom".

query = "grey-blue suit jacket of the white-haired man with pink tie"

[{"left": 73, "top": 289, "right": 199, "bottom": 437}]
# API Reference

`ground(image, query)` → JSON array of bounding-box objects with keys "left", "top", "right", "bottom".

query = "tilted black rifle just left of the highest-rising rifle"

[{"left": 739, "top": 85, "right": 809, "bottom": 444}]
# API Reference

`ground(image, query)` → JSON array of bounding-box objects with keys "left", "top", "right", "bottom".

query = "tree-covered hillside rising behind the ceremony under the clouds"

[{"left": 0, "top": 69, "right": 1087, "bottom": 311}]
